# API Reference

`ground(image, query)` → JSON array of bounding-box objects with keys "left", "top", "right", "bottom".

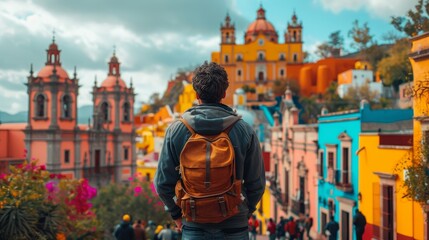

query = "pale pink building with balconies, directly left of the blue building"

[{"left": 270, "top": 86, "right": 318, "bottom": 236}]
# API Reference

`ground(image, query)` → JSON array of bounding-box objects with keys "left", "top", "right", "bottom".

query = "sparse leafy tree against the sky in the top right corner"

[{"left": 391, "top": 0, "right": 429, "bottom": 37}]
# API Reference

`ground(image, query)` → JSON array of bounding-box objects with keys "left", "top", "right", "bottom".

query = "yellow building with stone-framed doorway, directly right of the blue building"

[{"left": 357, "top": 133, "right": 425, "bottom": 239}]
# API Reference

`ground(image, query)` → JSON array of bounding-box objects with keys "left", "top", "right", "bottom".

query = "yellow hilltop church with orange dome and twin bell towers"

[{"left": 211, "top": 6, "right": 304, "bottom": 105}]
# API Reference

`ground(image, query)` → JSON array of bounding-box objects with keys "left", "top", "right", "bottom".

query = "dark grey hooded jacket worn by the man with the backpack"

[{"left": 154, "top": 104, "right": 265, "bottom": 229}]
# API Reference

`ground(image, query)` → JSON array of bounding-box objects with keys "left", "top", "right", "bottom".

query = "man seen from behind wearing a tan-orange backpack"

[{"left": 154, "top": 62, "right": 265, "bottom": 240}]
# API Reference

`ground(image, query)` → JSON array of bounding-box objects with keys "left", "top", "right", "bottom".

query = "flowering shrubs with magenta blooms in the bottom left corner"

[{"left": 0, "top": 161, "right": 97, "bottom": 240}]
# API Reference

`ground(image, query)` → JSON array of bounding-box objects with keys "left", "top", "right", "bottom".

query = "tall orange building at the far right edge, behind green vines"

[{"left": 410, "top": 32, "right": 429, "bottom": 239}]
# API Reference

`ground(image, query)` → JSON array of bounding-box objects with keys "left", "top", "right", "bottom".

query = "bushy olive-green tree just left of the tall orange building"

[{"left": 378, "top": 38, "right": 413, "bottom": 92}]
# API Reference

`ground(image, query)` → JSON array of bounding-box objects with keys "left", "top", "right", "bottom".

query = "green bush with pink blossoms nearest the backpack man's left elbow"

[{"left": 93, "top": 177, "right": 170, "bottom": 238}]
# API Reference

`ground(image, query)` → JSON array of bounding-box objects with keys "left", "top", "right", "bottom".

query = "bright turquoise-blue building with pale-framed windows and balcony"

[{"left": 317, "top": 100, "right": 413, "bottom": 239}]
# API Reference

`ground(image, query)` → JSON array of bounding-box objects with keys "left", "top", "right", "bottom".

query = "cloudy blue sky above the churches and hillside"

[{"left": 0, "top": 0, "right": 418, "bottom": 113}]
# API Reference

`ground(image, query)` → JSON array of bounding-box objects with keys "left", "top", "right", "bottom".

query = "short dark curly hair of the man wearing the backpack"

[{"left": 192, "top": 62, "right": 229, "bottom": 103}]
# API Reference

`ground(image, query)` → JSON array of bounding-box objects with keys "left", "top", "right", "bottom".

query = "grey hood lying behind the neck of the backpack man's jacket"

[{"left": 182, "top": 104, "right": 241, "bottom": 135}]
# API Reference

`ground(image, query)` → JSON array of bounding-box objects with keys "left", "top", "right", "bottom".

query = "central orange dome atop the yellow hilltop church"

[{"left": 245, "top": 6, "right": 278, "bottom": 42}]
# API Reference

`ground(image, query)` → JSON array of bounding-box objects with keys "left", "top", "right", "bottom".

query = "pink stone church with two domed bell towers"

[{"left": 0, "top": 40, "right": 136, "bottom": 186}]
